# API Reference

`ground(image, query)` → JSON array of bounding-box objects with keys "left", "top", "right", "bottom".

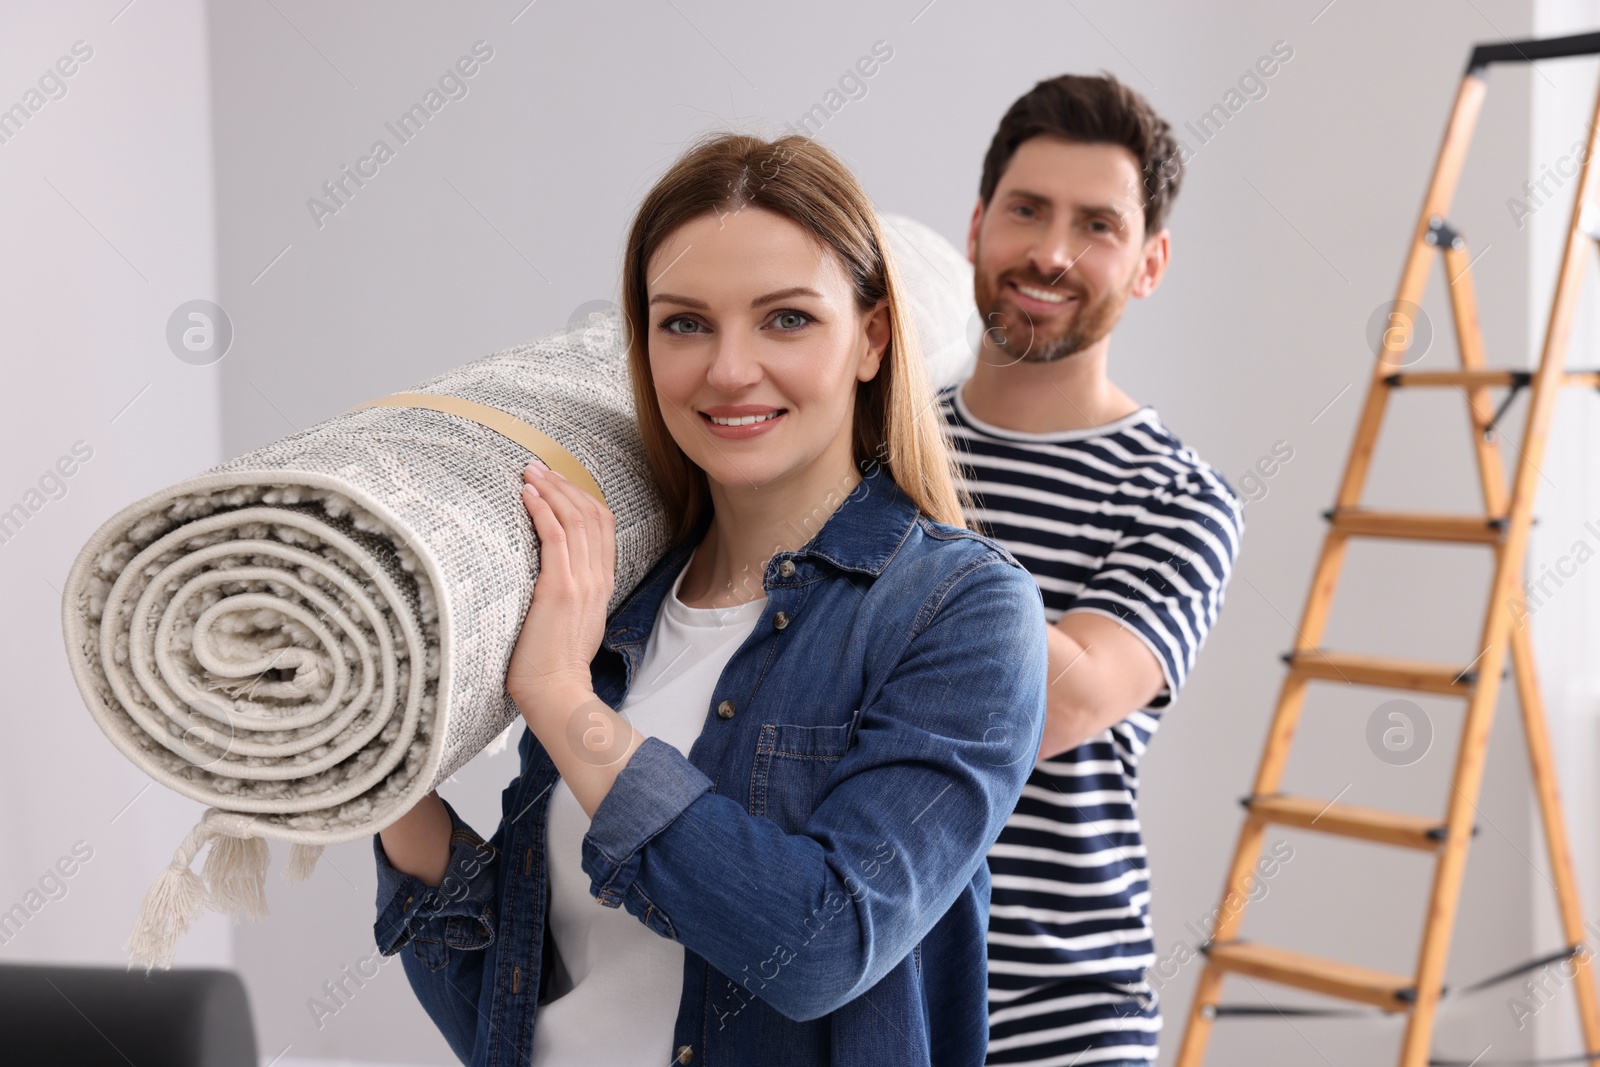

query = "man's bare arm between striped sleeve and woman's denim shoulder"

[{"left": 1038, "top": 611, "right": 1166, "bottom": 760}]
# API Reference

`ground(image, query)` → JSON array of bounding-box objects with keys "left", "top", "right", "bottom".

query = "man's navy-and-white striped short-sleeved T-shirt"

[{"left": 939, "top": 386, "right": 1245, "bottom": 1067}]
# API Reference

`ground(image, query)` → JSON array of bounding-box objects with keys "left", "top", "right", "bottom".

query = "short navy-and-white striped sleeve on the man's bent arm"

[{"left": 1066, "top": 469, "right": 1245, "bottom": 709}]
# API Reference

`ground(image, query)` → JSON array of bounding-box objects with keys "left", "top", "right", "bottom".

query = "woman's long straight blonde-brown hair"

[{"left": 622, "top": 133, "right": 968, "bottom": 544}]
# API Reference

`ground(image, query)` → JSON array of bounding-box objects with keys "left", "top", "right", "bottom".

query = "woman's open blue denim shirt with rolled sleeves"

[{"left": 373, "top": 467, "right": 1046, "bottom": 1067}]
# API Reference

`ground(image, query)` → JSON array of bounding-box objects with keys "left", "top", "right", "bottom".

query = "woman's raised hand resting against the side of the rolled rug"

[{"left": 506, "top": 459, "right": 616, "bottom": 717}]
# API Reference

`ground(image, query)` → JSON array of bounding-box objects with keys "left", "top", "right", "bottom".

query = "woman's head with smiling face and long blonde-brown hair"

[{"left": 622, "top": 136, "right": 965, "bottom": 550}]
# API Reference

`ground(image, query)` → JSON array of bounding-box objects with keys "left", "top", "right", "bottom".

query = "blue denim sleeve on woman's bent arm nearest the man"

[{"left": 582, "top": 550, "right": 1048, "bottom": 1021}]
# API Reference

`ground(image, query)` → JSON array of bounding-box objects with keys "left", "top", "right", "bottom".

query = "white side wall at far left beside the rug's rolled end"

[{"left": 0, "top": 0, "right": 232, "bottom": 965}]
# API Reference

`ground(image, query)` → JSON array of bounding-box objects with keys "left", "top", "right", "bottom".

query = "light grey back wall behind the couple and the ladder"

[{"left": 203, "top": 0, "right": 1531, "bottom": 1064}]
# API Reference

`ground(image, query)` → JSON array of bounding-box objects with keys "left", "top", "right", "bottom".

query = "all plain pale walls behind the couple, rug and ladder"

[{"left": 0, "top": 0, "right": 1600, "bottom": 1067}]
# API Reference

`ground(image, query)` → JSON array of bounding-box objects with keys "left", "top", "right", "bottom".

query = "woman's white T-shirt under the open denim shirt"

[{"left": 533, "top": 557, "right": 766, "bottom": 1067}]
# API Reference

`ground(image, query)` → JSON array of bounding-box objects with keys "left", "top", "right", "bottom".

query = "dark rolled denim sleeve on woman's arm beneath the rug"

[{"left": 373, "top": 797, "right": 499, "bottom": 971}]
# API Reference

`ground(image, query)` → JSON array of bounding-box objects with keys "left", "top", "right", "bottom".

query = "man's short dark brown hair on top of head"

[{"left": 978, "top": 72, "right": 1184, "bottom": 235}]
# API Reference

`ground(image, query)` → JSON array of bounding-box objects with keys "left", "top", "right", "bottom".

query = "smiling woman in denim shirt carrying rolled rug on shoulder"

[{"left": 373, "top": 134, "right": 1045, "bottom": 1067}]
